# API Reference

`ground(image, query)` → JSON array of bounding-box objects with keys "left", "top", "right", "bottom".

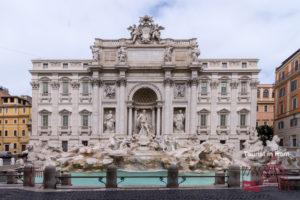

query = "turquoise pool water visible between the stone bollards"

[{"left": 36, "top": 171, "right": 249, "bottom": 187}]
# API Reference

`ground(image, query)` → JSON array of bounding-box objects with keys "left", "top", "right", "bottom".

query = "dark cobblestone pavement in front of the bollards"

[{"left": 0, "top": 188, "right": 300, "bottom": 200}]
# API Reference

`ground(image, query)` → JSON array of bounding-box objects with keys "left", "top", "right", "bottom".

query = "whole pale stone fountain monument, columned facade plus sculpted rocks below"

[{"left": 27, "top": 16, "right": 300, "bottom": 171}]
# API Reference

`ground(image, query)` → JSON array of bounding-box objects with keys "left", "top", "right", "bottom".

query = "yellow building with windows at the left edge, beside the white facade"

[{"left": 0, "top": 96, "right": 31, "bottom": 154}]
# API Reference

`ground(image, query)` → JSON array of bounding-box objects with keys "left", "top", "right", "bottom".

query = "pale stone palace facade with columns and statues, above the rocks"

[{"left": 31, "top": 16, "right": 259, "bottom": 150}]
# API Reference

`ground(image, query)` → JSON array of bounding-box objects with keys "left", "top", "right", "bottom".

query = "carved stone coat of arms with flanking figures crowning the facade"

[{"left": 128, "top": 15, "right": 164, "bottom": 43}]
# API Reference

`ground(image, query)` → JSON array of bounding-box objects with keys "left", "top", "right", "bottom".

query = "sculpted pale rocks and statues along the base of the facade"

[{"left": 28, "top": 132, "right": 300, "bottom": 171}]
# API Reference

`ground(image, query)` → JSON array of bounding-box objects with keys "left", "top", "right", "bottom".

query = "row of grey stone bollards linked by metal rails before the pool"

[{"left": 0, "top": 166, "right": 244, "bottom": 189}]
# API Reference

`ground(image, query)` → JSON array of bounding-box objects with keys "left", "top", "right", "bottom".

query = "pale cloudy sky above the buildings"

[{"left": 0, "top": 0, "right": 300, "bottom": 95}]
